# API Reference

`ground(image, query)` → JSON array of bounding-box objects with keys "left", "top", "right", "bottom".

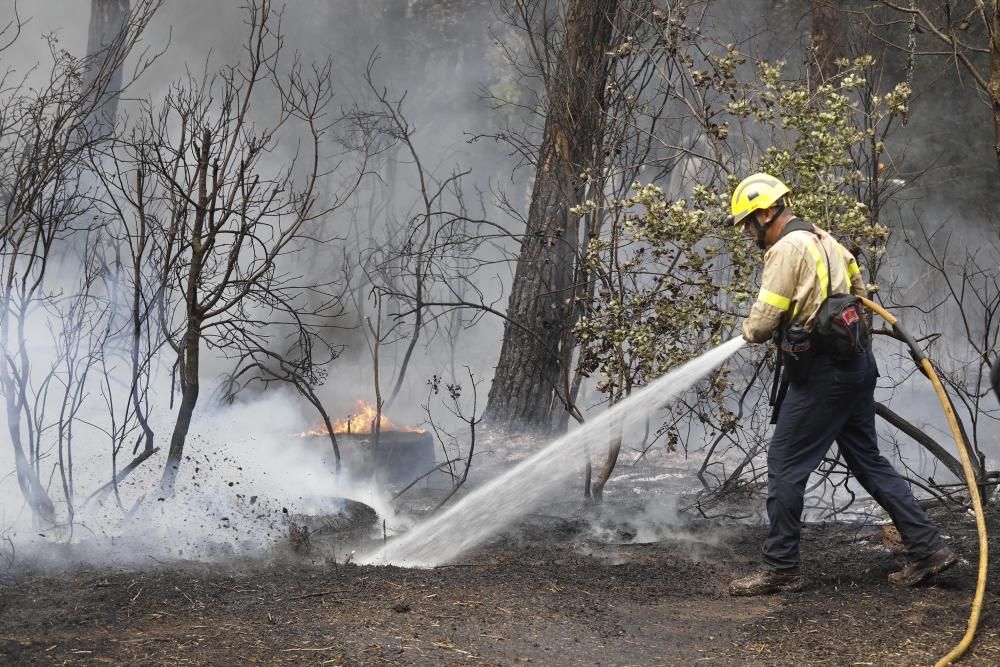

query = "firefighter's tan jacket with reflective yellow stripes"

[{"left": 743, "top": 222, "right": 867, "bottom": 343}]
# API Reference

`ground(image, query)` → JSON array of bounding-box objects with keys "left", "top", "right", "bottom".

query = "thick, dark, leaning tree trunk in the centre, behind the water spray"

[{"left": 484, "top": 0, "right": 618, "bottom": 432}]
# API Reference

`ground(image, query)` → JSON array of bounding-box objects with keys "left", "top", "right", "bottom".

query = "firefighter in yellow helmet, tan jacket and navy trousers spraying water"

[{"left": 727, "top": 173, "right": 958, "bottom": 595}]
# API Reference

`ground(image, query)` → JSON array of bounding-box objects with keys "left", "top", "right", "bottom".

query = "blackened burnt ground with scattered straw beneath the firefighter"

[{"left": 0, "top": 510, "right": 1000, "bottom": 665}]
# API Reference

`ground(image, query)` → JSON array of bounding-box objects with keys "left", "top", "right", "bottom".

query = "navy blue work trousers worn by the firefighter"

[{"left": 763, "top": 352, "right": 944, "bottom": 570}]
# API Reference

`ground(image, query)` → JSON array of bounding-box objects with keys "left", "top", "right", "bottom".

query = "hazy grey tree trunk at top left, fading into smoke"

[{"left": 87, "top": 0, "right": 129, "bottom": 136}]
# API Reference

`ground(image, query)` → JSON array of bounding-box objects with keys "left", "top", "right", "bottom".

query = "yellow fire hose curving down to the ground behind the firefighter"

[{"left": 861, "top": 298, "right": 989, "bottom": 667}]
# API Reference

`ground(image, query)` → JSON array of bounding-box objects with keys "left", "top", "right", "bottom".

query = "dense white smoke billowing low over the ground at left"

[{"left": 0, "top": 384, "right": 407, "bottom": 565}]
